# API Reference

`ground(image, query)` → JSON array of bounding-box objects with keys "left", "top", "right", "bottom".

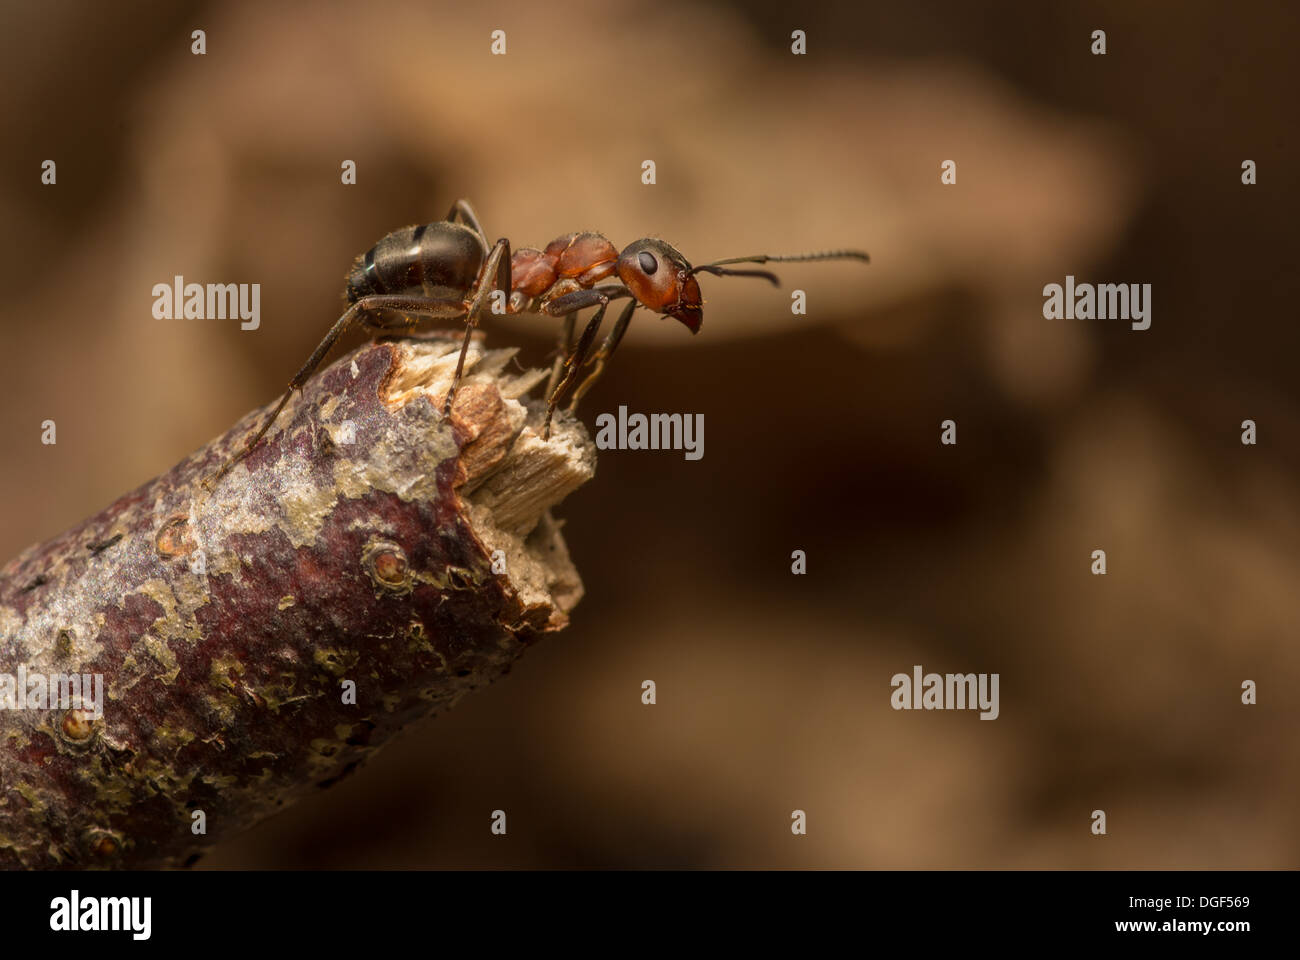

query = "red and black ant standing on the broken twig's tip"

[{"left": 208, "top": 200, "right": 870, "bottom": 487}]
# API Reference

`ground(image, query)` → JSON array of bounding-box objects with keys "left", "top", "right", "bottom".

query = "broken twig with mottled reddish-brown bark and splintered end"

[{"left": 0, "top": 341, "right": 595, "bottom": 868}]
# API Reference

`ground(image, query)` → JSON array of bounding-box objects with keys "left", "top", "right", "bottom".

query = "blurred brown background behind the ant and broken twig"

[{"left": 0, "top": 0, "right": 1300, "bottom": 868}]
